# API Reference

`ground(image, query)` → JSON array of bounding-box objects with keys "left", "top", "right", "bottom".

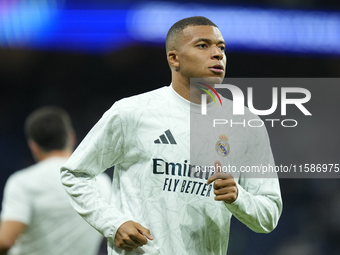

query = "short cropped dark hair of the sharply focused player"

[{"left": 165, "top": 16, "right": 217, "bottom": 53}]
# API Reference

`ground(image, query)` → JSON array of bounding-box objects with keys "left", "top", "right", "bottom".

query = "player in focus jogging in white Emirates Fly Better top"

[{"left": 61, "top": 17, "right": 282, "bottom": 255}]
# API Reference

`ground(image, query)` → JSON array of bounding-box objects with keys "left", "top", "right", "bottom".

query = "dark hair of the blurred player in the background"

[{"left": 25, "top": 106, "right": 73, "bottom": 152}]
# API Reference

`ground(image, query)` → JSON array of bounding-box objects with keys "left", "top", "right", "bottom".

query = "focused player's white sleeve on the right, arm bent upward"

[{"left": 225, "top": 115, "right": 282, "bottom": 233}]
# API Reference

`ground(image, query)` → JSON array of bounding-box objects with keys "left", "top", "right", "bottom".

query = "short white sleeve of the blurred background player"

[{"left": 1, "top": 174, "right": 32, "bottom": 225}]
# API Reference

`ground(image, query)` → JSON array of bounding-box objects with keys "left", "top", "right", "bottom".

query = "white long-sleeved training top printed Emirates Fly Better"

[{"left": 61, "top": 86, "right": 282, "bottom": 255}]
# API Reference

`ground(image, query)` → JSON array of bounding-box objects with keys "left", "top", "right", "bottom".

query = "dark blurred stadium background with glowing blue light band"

[{"left": 0, "top": 0, "right": 340, "bottom": 255}]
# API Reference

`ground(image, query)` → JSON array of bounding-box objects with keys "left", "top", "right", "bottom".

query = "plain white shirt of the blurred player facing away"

[{"left": 1, "top": 157, "right": 111, "bottom": 255}]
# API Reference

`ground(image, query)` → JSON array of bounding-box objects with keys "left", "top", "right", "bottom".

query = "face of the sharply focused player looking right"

[{"left": 177, "top": 26, "right": 227, "bottom": 83}]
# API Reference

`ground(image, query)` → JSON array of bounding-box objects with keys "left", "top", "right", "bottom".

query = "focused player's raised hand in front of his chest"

[{"left": 207, "top": 160, "right": 238, "bottom": 204}]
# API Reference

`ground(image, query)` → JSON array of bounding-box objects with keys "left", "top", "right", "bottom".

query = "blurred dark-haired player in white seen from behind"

[{"left": 0, "top": 106, "right": 111, "bottom": 255}]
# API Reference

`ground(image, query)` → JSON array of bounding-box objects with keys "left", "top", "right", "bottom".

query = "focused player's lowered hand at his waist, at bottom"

[{"left": 115, "top": 221, "right": 153, "bottom": 251}]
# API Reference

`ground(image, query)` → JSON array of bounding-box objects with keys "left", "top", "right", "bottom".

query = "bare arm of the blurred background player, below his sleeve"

[{"left": 0, "top": 221, "right": 26, "bottom": 252}]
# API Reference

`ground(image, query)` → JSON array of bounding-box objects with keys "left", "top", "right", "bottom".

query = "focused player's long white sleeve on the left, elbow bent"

[{"left": 61, "top": 104, "right": 132, "bottom": 239}]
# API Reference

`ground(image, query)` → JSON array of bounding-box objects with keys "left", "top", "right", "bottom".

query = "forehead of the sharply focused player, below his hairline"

[{"left": 182, "top": 26, "right": 224, "bottom": 42}]
